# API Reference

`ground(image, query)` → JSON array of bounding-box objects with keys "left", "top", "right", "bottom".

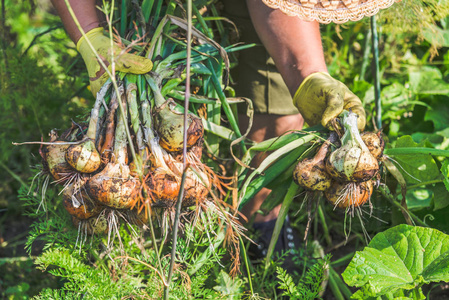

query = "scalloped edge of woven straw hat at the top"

[{"left": 262, "top": 0, "right": 395, "bottom": 24}]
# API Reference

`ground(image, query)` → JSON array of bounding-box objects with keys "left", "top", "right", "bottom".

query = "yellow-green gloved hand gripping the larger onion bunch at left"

[{"left": 76, "top": 27, "right": 153, "bottom": 96}]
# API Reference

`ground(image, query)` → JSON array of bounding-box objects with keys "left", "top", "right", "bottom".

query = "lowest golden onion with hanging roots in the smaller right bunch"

[{"left": 324, "top": 181, "right": 373, "bottom": 209}]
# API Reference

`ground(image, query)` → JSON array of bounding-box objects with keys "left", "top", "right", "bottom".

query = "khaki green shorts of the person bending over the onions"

[{"left": 223, "top": 0, "right": 299, "bottom": 115}]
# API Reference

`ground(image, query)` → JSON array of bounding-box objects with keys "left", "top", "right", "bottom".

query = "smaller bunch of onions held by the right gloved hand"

[{"left": 293, "top": 112, "right": 385, "bottom": 210}]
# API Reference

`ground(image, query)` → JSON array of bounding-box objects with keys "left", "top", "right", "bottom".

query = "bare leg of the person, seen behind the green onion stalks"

[{"left": 239, "top": 114, "right": 304, "bottom": 223}]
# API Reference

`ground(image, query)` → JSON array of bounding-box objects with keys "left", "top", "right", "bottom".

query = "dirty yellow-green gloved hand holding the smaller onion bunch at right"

[{"left": 293, "top": 72, "right": 366, "bottom": 131}]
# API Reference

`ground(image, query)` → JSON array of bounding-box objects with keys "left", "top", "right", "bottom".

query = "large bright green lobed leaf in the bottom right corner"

[{"left": 342, "top": 224, "right": 449, "bottom": 299}]
